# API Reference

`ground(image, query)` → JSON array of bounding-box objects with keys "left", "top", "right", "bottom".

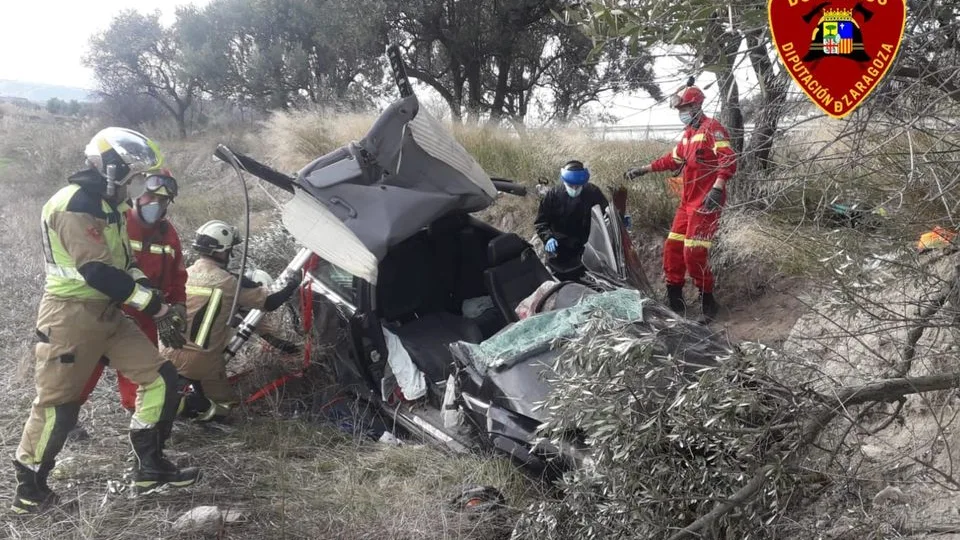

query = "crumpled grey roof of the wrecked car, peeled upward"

[{"left": 284, "top": 95, "right": 497, "bottom": 277}]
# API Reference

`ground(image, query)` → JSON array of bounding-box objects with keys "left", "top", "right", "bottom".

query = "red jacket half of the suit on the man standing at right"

[{"left": 650, "top": 116, "right": 737, "bottom": 209}]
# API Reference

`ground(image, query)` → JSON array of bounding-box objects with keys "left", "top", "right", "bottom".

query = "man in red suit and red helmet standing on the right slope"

[{"left": 626, "top": 79, "right": 737, "bottom": 323}]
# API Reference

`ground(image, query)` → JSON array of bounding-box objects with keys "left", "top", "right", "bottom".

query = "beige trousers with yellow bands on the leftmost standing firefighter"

[{"left": 16, "top": 295, "right": 180, "bottom": 468}]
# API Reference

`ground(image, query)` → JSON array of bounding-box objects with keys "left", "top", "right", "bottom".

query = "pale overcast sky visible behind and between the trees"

[{"left": 0, "top": 0, "right": 756, "bottom": 126}]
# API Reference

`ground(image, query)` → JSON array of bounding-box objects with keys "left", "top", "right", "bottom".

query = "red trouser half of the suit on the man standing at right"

[{"left": 663, "top": 206, "right": 720, "bottom": 293}]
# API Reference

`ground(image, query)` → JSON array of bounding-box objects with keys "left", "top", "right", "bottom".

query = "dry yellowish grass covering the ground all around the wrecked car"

[{"left": 0, "top": 99, "right": 948, "bottom": 539}]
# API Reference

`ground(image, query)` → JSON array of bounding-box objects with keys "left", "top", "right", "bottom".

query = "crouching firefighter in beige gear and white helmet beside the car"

[{"left": 161, "top": 220, "right": 301, "bottom": 421}]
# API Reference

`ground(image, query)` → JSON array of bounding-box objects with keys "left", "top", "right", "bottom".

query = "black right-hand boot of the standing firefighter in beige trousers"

[{"left": 130, "top": 421, "right": 200, "bottom": 495}]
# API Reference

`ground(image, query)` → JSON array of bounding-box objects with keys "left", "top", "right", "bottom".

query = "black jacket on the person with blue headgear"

[{"left": 534, "top": 183, "right": 610, "bottom": 263}]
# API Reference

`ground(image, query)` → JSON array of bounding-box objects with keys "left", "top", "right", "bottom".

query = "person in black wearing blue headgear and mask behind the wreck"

[{"left": 534, "top": 160, "right": 610, "bottom": 281}]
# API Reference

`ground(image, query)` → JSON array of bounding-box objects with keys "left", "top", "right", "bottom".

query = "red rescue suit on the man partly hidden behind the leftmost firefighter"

[{"left": 81, "top": 208, "right": 187, "bottom": 410}]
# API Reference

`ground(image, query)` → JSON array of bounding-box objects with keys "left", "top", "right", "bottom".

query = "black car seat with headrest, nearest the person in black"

[{"left": 484, "top": 233, "right": 554, "bottom": 322}]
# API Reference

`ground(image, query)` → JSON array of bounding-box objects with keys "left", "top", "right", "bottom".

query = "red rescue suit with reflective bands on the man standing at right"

[{"left": 650, "top": 115, "right": 737, "bottom": 293}]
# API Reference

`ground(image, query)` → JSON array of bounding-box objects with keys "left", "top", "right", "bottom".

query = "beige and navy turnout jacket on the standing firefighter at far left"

[{"left": 40, "top": 169, "right": 161, "bottom": 316}]
